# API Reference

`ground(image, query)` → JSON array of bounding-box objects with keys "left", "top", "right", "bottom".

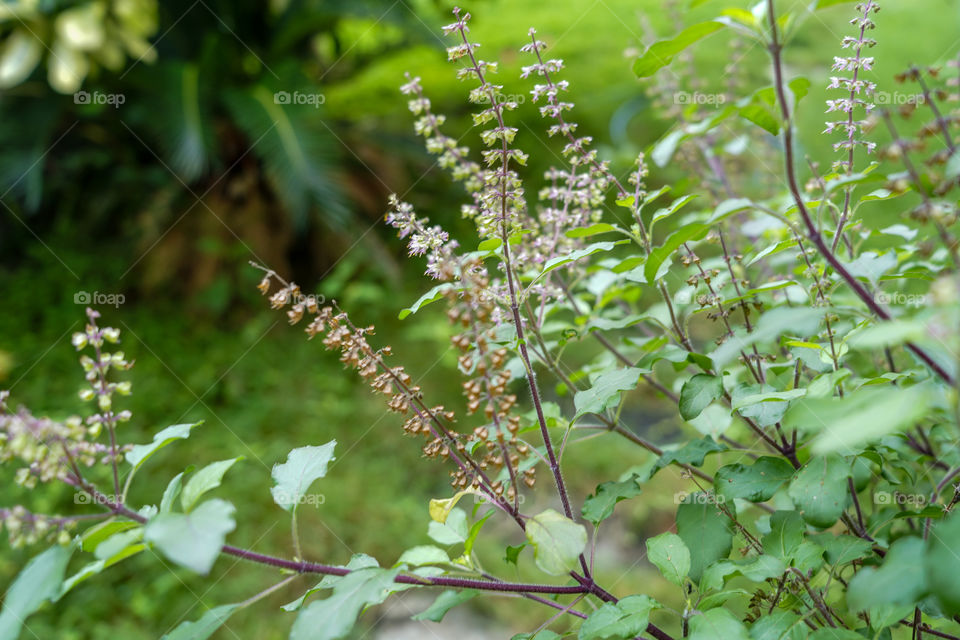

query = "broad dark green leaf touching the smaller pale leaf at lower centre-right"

[{"left": 677, "top": 491, "right": 733, "bottom": 582}]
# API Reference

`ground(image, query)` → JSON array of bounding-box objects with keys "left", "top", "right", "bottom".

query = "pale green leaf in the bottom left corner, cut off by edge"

[{"left": 0, "top": 545, "right": 72, "bottom": 640}]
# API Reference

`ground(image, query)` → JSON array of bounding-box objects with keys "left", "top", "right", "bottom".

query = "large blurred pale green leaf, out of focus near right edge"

[{"left": 783, "top": 385, "right": 934, "bottom": 454}]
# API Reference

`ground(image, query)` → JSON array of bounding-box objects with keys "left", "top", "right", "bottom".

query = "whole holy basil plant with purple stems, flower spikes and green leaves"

[{"left": 0, "top": 0, "right": 960, "bottom": 640}]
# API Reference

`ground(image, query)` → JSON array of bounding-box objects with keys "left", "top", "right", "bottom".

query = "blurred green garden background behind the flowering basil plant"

[{"left": 0, "top": 0, "right": 958, "bottom": 640}]
